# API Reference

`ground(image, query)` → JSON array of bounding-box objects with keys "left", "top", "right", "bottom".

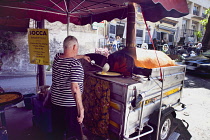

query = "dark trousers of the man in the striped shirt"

[{"left": 52, "top": 105, "right": 81, "bottom": 140}]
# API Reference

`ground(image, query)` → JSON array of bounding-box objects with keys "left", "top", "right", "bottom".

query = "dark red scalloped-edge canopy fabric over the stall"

[{"left": 0, "top": 0, "right": 188, "bottom": 25}]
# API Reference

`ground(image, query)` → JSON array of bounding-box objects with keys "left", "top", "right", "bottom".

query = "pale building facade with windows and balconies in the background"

[{"left": 105, "top": 0, "right": 210, "bottom": 46}]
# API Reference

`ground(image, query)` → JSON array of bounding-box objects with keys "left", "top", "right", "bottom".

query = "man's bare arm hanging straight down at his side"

[{"left": 71, "top": 83, "right": 84, "bottom": 124}]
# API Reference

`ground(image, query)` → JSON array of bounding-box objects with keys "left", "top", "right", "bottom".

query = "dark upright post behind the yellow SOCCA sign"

[{"left": 36, "top": 20, "right": 46, "bottom": 86}]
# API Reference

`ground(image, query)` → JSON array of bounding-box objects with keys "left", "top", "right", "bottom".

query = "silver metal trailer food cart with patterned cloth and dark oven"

[{"left": 83, "top": 48, "right": 185, "bottom": 140}]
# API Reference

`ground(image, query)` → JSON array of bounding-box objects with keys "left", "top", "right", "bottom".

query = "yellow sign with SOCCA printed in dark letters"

[{"left": 28, "top": 29, "right": 50, "bottom": 65}]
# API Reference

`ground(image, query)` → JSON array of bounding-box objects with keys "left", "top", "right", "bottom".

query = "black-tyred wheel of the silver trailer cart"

[{"left": 152, "top": 114, "right": 173, "bottom": 140}]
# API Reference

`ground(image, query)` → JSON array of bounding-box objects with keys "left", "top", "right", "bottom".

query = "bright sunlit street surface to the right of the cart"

[{"left": 177, "top": 74, "right": 210, "bottom": 140}]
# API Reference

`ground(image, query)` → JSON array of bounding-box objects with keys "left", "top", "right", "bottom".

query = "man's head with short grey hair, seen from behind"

[{"left": 63, "top": 36, "right": 79, "bottom": 55}]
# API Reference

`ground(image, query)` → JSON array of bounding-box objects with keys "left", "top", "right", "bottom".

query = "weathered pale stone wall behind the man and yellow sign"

[{"left": 1, "top": 21, "right": 104, "bottom": 73}]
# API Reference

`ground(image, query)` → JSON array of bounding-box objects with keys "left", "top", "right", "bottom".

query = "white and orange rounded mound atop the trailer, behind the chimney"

[{"left": 134, "top": 48, "right": 176, "bottom": 69}]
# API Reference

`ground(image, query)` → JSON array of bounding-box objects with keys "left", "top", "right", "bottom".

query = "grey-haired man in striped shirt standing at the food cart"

[{"left": 51, "top": 36, "right": 90, "bottom": 140}]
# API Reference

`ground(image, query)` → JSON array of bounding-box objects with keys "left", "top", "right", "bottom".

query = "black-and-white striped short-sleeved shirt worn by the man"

[{"left": 51, "top": 53, "right": 84, "bottom": 107}]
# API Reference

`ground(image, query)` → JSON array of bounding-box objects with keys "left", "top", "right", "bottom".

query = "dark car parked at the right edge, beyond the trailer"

[{"left": 182, "top": 55, "right": 210, "bottom": 75}]
